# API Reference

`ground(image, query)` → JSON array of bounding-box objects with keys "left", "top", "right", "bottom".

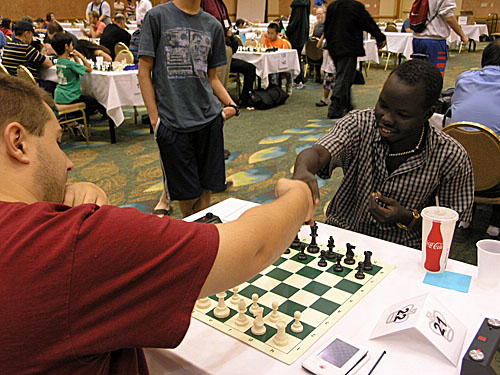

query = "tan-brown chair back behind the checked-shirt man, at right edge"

[{"left": 443, "top": 121, "right": 500, "bottom": 191}]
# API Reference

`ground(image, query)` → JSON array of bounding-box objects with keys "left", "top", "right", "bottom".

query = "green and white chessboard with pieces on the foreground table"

[{"left": 193, "top": 227, "right": 395, "bottom": 364}]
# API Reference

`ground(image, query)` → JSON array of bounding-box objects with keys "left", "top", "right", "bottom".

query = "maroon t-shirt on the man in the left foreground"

[{"left": 0, "top": 202, "right": 219, "bottom": 375}]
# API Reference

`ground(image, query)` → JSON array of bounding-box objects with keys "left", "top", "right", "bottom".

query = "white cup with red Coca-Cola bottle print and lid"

[{"left": 421, "top": 207, "right": 458, "bottom": 273}]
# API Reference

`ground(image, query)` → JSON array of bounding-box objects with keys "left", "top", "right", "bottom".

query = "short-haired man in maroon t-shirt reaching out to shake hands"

[{"left": 0, "top": 75, "right": 315, "bottom": 375}]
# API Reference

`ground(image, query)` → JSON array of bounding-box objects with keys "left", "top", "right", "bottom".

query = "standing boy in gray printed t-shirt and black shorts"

[{"left": 139, "top": 0, "right": 239, "bottom": 217}]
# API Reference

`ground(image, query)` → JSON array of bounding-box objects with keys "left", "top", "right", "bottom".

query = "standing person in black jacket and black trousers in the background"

[{"left": 325, "top": 0, "right": 385, "bottom": 119}]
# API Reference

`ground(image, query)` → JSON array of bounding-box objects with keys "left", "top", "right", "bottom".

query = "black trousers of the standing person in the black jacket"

[{"left": 328, "top": 56, "right": 357, "bottom": 118}]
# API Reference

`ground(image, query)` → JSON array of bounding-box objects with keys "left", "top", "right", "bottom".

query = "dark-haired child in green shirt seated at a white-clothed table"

[{"left": 50, "top": 33, "right": 106, "bottom": 132}]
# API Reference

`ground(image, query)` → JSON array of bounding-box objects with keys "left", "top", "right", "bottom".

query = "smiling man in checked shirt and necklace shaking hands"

[{"left": 293, "top": 60, "right": 474, "bottom": 248}]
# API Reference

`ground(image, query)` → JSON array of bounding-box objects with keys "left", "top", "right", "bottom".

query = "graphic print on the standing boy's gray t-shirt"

[{"left": 164, "top": 28, "right": 212, "bottom": 79}]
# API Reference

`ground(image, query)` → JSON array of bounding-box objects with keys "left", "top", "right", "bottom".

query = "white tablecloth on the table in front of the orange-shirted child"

[{"left": 233, "top": 49, "right": 300, "bottom": 87}]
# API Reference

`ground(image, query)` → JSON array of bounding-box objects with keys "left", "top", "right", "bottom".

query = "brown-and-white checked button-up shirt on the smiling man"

[{"left": 316, "top": 108, "right": 474, "bottom": 248}]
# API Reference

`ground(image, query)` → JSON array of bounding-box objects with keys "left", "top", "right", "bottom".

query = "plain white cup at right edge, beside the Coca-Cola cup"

[{"left": 477, "top": 240, "right": 500, "bottom": 288}]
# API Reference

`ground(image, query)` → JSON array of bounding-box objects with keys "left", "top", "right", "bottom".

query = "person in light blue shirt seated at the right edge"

[{"left": 451, "top": 39, "right": 500, "bottom": 241}]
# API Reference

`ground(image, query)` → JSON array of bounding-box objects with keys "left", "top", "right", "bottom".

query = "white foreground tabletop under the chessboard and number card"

[{"left": 146, "top": 198, "right": 500, "bottom": 375}]
